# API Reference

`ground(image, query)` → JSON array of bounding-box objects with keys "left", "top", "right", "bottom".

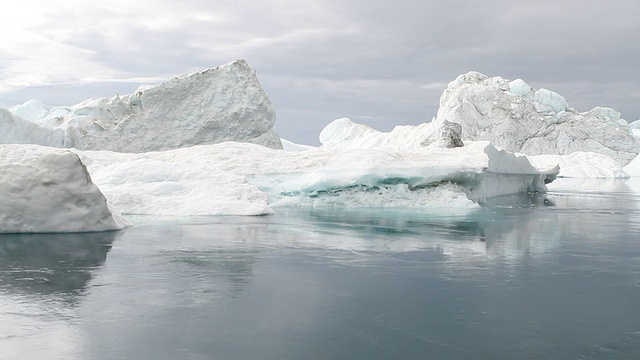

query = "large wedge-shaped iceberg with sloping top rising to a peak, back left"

[{"left": 0, "top": 60, "right": 282, "bottom": 152}]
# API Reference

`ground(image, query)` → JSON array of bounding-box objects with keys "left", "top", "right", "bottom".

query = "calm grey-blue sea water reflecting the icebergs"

[{"left": 0, "top": 180, "right": 640, "bottom": 359}]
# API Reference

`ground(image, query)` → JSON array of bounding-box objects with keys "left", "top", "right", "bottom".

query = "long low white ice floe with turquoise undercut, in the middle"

[{"left": 72, "top": 142, "right": 558, "bottom": 215}]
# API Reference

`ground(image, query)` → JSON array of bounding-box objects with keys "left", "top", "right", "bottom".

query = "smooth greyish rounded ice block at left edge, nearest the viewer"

[{"left": 0, "top": 145, "right": 127, "bottom": 233}]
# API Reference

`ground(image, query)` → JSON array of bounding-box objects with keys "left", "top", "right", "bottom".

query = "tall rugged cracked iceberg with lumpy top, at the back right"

[{"left": 435, "top": 72, "right": 640, "bottom": 166}]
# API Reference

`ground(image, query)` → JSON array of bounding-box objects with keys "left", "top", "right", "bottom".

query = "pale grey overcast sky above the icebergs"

[{"left": 0, "top": 0, "right": 640, "bottom": 144}]
